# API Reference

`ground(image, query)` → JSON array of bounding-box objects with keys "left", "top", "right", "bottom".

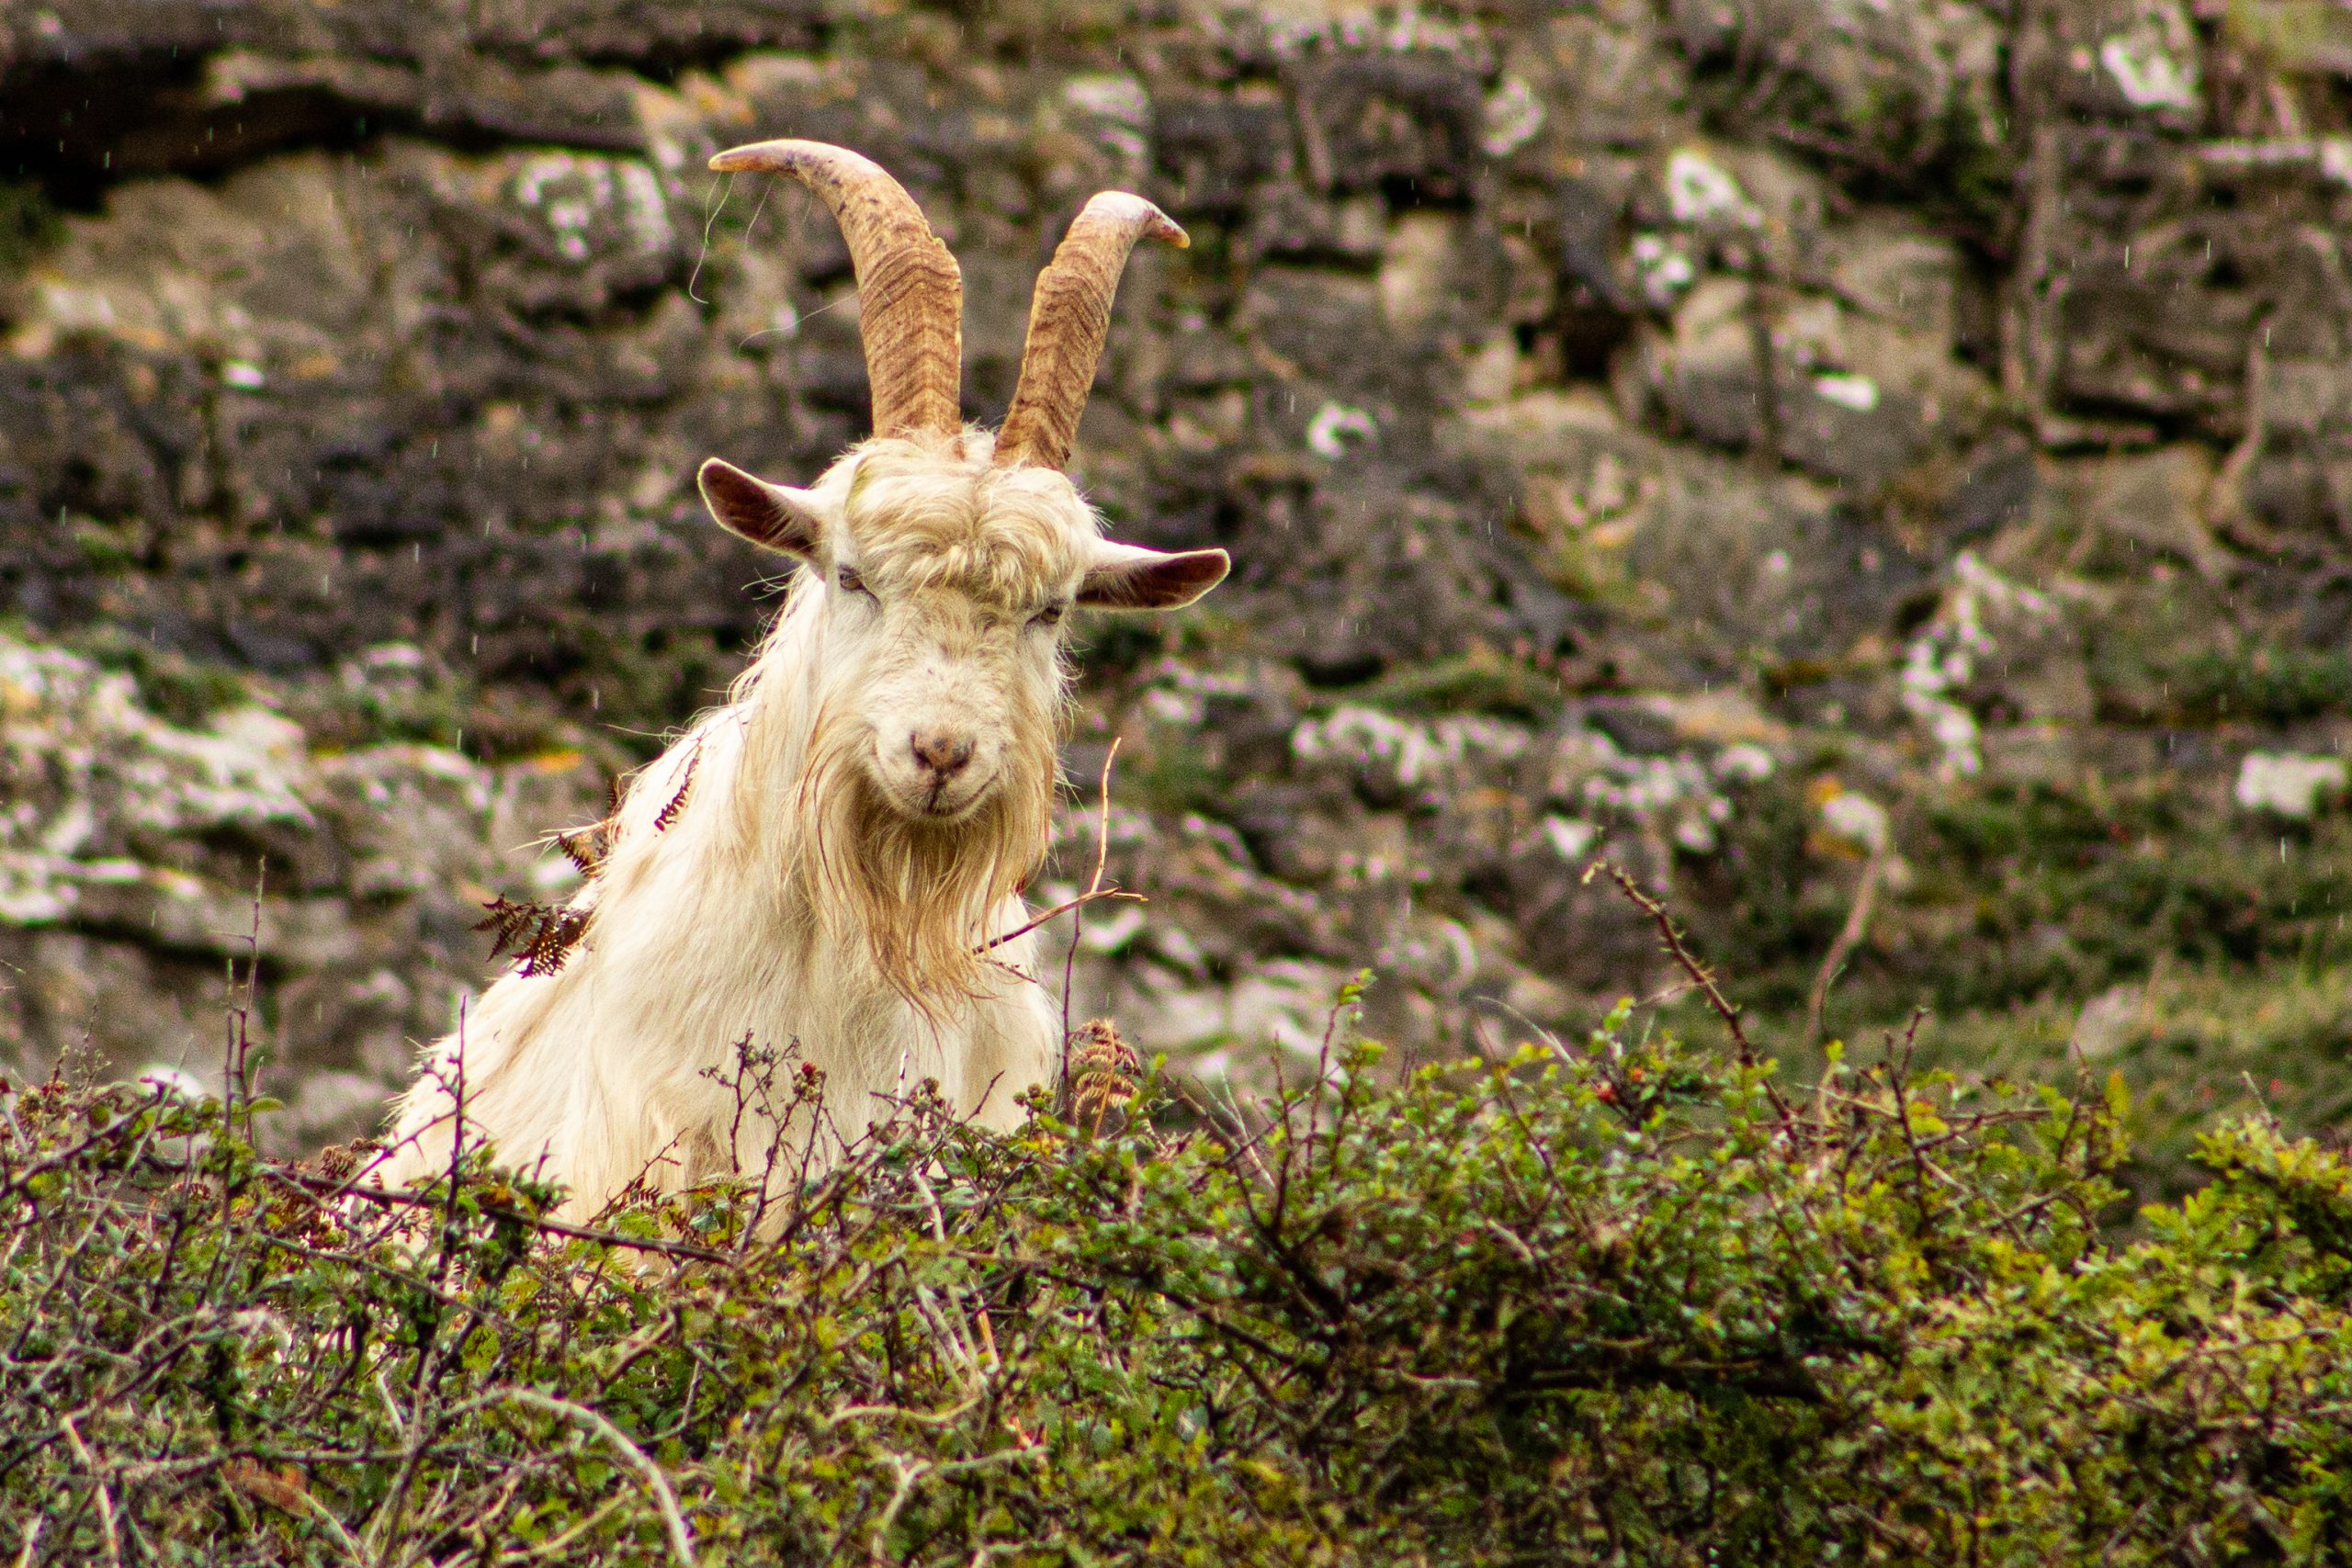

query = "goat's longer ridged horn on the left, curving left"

[{"left": 710, "top": 141, "right": 965, "bottom": 434}]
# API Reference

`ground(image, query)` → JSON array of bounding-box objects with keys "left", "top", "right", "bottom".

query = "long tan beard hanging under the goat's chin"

[{"left": 795, "top": 709, "right": 1054, "bottom": 1022}]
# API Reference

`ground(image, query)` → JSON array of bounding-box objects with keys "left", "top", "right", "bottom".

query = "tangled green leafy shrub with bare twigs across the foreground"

[{"left": 0, "top": 1009, "right": 2352, "bottom": 1565}]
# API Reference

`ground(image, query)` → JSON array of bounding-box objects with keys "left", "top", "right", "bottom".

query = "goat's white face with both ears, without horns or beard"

[{"left": 701, "top": 430, "right": 1226, "bottom": 828}]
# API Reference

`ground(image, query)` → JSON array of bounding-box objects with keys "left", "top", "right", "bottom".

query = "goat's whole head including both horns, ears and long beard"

[{"left": 701, "top": 139, "right": 1227, "bottom": 999}]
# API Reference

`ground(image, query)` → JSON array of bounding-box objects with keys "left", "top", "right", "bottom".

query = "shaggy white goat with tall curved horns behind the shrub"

[{"left": 377, "top": 141, "right": 1227, "bottom": 1213}]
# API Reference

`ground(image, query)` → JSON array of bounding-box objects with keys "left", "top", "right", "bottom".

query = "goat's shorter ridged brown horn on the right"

[{"left": 995, "top": 190, "right": 1190, "bottom": 468}]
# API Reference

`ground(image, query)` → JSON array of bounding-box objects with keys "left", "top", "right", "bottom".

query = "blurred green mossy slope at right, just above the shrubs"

[{"left": 1721, "top": 778, "right": 2352, "bottom": 1170}]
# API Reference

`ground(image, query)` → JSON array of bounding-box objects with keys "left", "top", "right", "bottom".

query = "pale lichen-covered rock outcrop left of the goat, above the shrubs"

[{"left": 0, "top": 637, "right": 595, "bottom": 1135}]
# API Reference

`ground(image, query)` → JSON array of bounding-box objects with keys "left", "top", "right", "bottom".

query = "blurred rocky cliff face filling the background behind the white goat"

[{"left": 0, "top": 0, "right": 2352, "bottom": 1182}]
